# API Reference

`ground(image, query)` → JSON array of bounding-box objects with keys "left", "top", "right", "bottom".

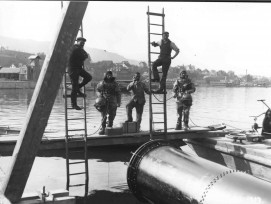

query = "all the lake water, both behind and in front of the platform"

[{"left": 0, "top": 87, "right": 271, "bottom": 204}]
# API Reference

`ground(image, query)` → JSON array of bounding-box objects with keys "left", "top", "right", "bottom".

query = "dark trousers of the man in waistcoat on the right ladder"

[{"left": 152, "top": 58, "right": 171, "bottom": 89}]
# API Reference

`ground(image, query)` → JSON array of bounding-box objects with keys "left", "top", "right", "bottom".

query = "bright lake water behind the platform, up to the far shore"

[{"left": 0, "top": 87, "right": 271, "bottom": 136}]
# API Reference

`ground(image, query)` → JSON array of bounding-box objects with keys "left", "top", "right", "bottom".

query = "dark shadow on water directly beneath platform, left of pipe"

[{"left": 38, "top": 145, "right": 139, "bottom": 162}]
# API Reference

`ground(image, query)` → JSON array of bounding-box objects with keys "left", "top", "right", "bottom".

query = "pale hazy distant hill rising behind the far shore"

[{"left": 0, "top": 36, "right": 139, "bottom": 65}]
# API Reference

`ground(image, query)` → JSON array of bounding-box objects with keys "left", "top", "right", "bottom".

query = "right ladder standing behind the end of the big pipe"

[{"left": 147, "top": 6, "right": 167, "bottom": 140}]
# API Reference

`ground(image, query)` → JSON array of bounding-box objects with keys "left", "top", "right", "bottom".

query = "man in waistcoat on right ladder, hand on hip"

[{"left": 151, "top": 32, "right": 180, "bottom": 93}]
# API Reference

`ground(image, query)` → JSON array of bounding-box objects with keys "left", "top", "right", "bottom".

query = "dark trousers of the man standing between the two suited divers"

[{"left": 126, "top": 99, "right": 144, "bottom": 127}]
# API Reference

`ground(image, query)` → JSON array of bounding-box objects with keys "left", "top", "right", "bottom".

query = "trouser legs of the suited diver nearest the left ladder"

[{"left": 101, "top": 101, "right": 117, "bottom": 128}]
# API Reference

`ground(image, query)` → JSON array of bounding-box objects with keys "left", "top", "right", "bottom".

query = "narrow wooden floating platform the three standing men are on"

[{"left": 0, "top": 127, "right": 227, "bottom": 154}]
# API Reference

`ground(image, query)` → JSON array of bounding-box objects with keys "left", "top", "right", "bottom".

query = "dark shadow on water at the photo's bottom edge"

[{"left": 76, "top": 190, "right": 146, "bottom": 204}]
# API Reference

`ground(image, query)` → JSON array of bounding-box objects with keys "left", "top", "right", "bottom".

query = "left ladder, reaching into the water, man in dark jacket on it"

[{"left": 63, "top": 24, "right": 89, "bottom": 198}]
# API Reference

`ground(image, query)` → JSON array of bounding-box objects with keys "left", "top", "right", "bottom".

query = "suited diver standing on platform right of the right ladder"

[{"left": 173, "top": 70, "right": 196, "bottom": 130}]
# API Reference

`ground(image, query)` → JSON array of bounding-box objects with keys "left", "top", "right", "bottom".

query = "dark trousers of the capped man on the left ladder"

[{"left": 69, "top": 69, "right": 92, "bottom": 106}]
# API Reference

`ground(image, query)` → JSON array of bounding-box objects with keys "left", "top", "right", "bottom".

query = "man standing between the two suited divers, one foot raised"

[{"left": 125, "top": 72, "right": 150, "bottom": 130}]
